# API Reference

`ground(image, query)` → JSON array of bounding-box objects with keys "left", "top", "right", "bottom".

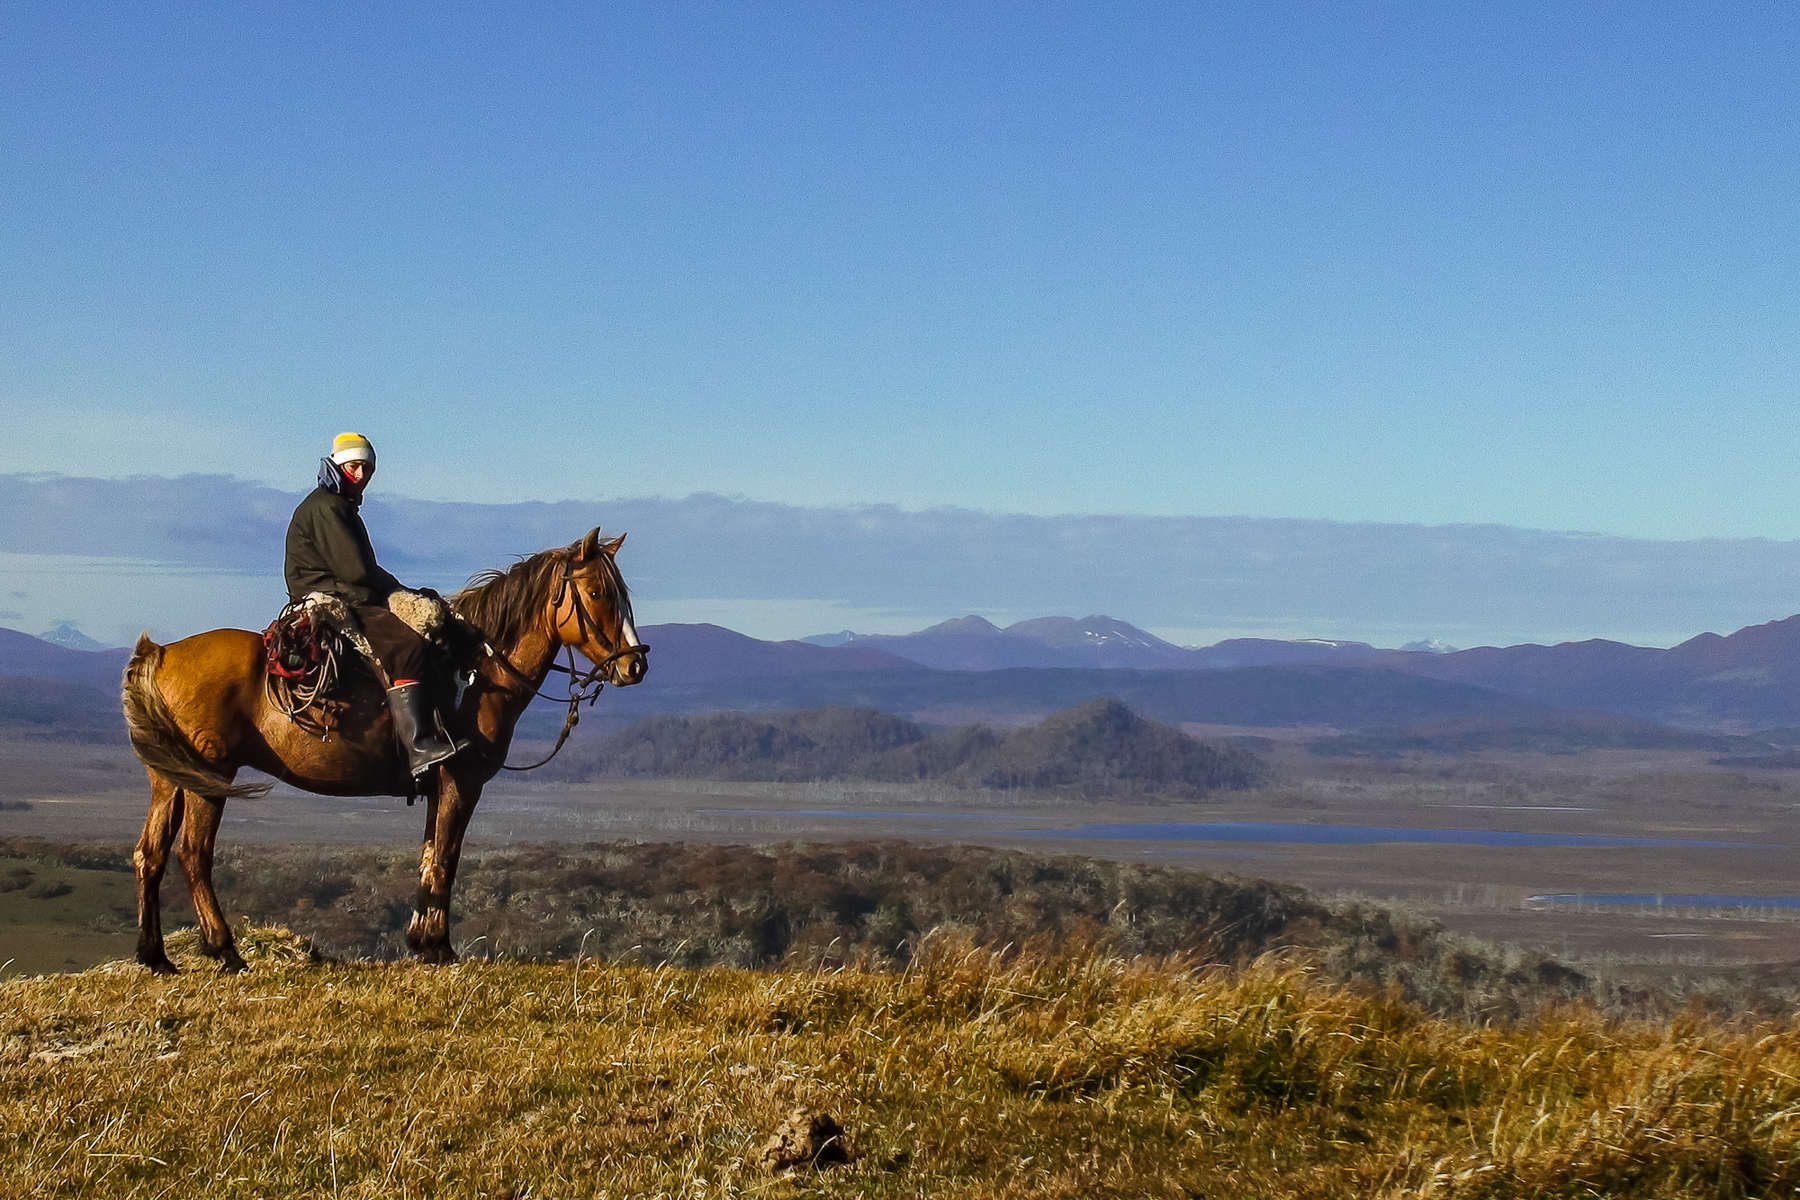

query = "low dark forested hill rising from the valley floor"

[{"left": 547, "top": 700, "right": 1265, "bottom": 797}]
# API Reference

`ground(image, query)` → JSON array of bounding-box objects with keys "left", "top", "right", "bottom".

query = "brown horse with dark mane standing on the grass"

[{"left": 124, "top": 529, "right": 648, "bottom": 975}]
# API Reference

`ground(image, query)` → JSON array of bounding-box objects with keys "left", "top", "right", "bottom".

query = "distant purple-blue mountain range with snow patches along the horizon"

[{"left": 10, "top": 615, "right": 1800, "bottom": 745}]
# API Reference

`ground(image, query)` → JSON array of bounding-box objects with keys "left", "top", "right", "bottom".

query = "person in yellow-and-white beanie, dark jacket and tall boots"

[{"left": 284, "top": 434, "right": 466, "bottom": 775}]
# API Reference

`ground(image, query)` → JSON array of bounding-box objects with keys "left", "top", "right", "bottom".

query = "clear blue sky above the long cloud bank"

[{"left": 0, "top": 2, "right": 1800, "bottom": 564}]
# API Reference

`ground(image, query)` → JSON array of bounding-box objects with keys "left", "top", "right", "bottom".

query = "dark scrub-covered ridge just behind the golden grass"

[{"left": 0, "top": 837, "right": 1605, "bottom": 1020}]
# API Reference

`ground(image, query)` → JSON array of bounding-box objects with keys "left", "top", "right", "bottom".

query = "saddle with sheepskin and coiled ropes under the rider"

[{"left": 263, "top": 590, "right": 482, "bottom": 732}]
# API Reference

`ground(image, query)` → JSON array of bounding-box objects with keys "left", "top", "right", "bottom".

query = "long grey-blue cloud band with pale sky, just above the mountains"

[{"left": 0, "top": 475, "right": 1800, "bottom": 646}]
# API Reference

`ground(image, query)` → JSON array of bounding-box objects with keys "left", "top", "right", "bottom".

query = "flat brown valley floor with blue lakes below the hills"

[{"left": 0, "top": 729, "right": 1800, "bottom": 982}]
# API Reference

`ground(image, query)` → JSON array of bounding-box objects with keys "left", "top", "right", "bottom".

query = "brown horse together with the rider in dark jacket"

[{"left": 121, "top": 482, "right": 650, "bottom": 975}]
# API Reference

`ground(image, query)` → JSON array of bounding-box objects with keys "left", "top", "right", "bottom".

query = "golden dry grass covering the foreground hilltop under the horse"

[{"left": 0, "top": 930, "right": 1800, "bottom": 1200}]
